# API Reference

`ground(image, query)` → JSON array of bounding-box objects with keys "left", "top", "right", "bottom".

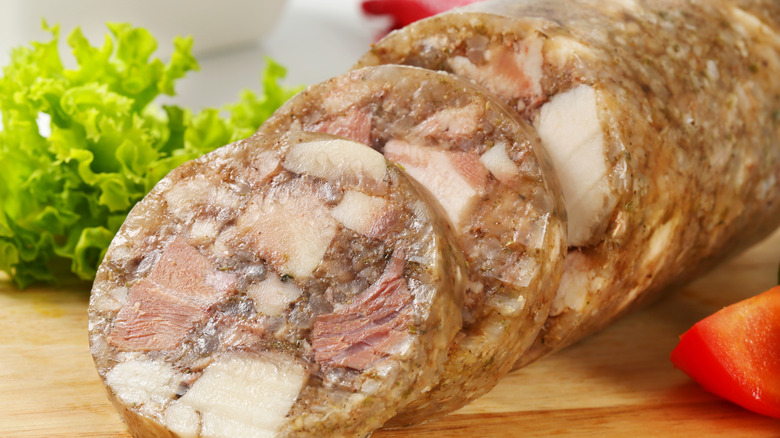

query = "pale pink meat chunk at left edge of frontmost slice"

[{"left": 109, "top": 239, "right": 236, "bottom": 351}]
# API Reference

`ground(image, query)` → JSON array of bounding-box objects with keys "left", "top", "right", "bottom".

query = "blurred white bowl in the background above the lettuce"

[{"left": 0, "top": 0, "right": 285, "bottom": 66}]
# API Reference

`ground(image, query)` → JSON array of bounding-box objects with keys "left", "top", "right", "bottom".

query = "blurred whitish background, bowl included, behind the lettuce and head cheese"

[{"left": 0, "top": 0, "right": 386, "bottom": 110}]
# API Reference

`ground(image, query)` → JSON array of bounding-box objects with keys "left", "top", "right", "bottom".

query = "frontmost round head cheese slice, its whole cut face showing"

[{"left": 89, "top": 133, "right": 467, "bottom": 437}]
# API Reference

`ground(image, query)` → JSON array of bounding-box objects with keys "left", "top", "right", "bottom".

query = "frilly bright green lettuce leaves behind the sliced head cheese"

[{"left": 0, "top": 24, "right": 299, "bottom": 288}]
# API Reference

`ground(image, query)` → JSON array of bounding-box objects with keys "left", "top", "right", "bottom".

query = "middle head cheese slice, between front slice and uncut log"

[{"left": 260, "top": 66, "right": 565, "bottom": 425}]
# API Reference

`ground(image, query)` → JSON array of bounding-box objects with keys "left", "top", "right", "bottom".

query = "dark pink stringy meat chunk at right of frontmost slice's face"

[{"left": 312, "top": 256, "right": 412, "bottom": 370}]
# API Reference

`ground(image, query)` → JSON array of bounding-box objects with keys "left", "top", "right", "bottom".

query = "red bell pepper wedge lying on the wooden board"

[{"left": 671, "top": 286, "right": 780, "bottom": 418}]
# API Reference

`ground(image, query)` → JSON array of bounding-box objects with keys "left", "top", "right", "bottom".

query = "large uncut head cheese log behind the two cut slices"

[{"left": 358, "top": 0, "right": 780, "bottom": 364}]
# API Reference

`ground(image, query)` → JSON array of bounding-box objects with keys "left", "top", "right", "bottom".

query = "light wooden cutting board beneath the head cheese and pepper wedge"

[{"left": 0, "top": 228, "right": 780, "bottom": 438}]
